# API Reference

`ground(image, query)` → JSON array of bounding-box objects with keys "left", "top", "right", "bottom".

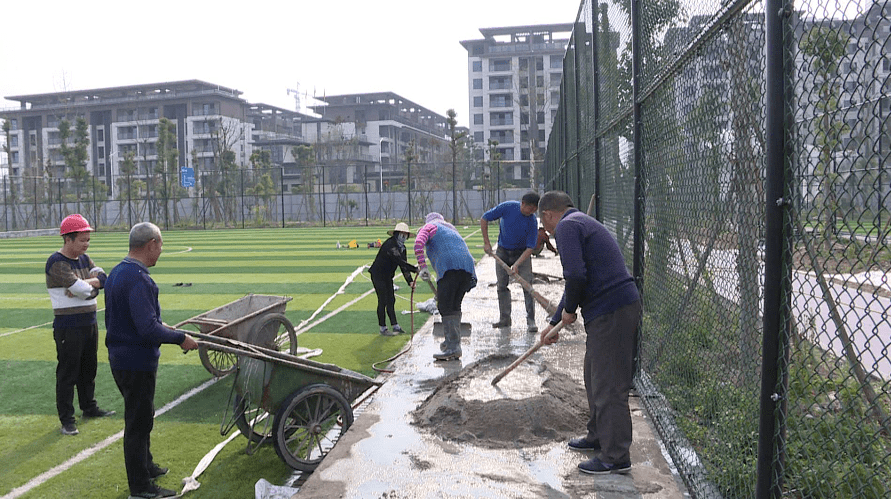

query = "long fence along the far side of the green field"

[{"left": 0, "top": 161, "right": 541, "bottom": 231}]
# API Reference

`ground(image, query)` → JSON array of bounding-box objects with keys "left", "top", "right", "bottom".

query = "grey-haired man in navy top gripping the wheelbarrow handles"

[{"left": 105, "top": 222, "right": 198, "bottom": 499}]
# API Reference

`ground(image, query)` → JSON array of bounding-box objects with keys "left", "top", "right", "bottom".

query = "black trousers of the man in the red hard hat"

[{"left": 53, "top": 324, "right": 99, "bottom": 425}]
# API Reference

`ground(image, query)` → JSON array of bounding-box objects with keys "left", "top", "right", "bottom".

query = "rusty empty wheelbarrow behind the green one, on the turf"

[{"left": 173, "top": 294, "right": 297, "bottom": 377}]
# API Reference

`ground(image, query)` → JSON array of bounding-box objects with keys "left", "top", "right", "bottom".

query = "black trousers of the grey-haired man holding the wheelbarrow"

[{"left": 111, "top": 369, "right": 157, "bottom": 494}]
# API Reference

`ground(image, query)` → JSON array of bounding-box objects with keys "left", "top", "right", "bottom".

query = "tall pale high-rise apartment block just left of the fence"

[{"left": 461, "top": 23, "right": 573, "bottom": 186}]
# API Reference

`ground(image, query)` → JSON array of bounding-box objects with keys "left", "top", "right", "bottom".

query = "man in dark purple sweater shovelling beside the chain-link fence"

[{"left": 538, "top": 191, "right": 641, "bottom": 474}]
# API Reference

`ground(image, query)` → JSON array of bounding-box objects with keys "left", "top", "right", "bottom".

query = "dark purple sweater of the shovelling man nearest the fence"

[{"left": 551, "top": 208, "right": 640, "bottom": 323}]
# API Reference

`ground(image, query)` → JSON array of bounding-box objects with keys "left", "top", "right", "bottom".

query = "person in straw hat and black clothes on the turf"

[{"left": 369, "top": 222, "right": 418, "bottom": 336}]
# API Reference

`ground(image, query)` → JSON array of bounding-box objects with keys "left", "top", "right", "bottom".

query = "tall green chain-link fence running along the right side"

[{"left": 545, "top": 0, "right": 891, "bottom": 498}]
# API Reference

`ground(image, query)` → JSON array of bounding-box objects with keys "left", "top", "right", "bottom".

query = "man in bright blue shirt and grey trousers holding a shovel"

[{"left": 480, "top": 192, "right": 539, "bottom": 333}]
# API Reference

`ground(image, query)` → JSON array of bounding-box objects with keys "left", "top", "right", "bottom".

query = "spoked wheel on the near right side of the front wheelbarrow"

[{"left": 273, "top": 384, "right": 353, "bottom": 472}]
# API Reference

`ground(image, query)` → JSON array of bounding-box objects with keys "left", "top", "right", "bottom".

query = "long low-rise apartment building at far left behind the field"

[{"left": 2, "top": 80, "right": 254, "bottom": 196}]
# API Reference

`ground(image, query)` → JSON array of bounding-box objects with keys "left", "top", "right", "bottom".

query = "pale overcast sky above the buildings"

[{"left": 0, "top": 0, "right": 581, "bottom": 126}]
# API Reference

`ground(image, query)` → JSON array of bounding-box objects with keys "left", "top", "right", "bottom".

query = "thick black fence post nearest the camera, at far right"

[{"left": 755, "top": 0, "right": 792, "bottom": 499}]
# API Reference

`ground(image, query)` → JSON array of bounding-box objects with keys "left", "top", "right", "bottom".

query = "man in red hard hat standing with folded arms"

[{"left": 46, "top": 214, "right": 115, "bottom": 435}]
